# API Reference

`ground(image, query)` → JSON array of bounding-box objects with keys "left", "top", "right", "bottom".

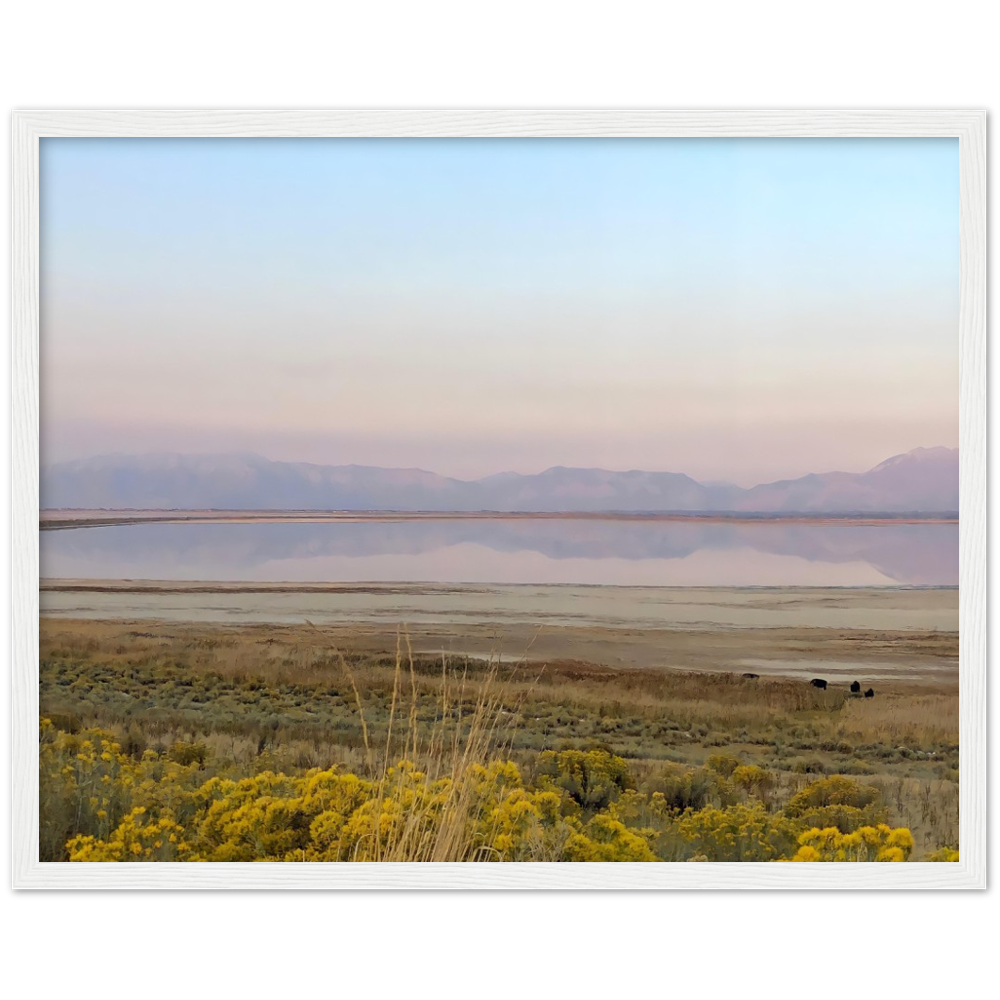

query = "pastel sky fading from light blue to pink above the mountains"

[{"left": 41, "top": 138, "right": 959, "bottom": 485}]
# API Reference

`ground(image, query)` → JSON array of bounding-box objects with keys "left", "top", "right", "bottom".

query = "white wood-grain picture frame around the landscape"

[{"left": 11, "top": 109, "right": 986, "bottom": 891}]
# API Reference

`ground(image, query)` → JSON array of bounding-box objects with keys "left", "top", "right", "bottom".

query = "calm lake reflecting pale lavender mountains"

[{"left": 40, "top": 517, "right": 958, "bottom": 587}]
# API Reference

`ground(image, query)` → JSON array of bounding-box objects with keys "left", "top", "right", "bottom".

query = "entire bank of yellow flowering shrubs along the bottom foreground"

[{"left": 39, "top": 719, "right": 944, "bottom": 862}]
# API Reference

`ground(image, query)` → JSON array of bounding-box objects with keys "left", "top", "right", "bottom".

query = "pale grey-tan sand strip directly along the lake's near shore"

[{"left": 41, "top": 580, "right": 958, "bottom": 632}]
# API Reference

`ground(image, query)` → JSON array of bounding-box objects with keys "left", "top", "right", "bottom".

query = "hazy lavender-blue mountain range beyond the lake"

[{"left": 41, "top": 448, "right": 958, "bottom": 513}]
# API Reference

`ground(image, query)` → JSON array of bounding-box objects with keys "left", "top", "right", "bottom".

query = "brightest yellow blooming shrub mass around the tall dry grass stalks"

[{"left": 54, "top": 748, "right": 656, "bottom": 861}]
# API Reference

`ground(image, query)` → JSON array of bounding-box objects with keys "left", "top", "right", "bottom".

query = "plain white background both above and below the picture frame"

[{"left": 7, "top": 0, "right": 997, "bottom": 1000}]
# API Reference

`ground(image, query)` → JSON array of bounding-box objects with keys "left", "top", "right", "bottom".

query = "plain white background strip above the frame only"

[{"left": 0, "top": 0, "right": 998, "bottom": 97}]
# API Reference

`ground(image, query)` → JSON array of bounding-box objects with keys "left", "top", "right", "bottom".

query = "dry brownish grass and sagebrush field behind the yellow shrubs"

[{"left": 40, "top": 619, "right": 958, "bottom": 860}]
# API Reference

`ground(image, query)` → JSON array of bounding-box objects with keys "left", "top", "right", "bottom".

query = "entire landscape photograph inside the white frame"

[{"left": 30, "top": 126, "right": 964, "bottom": 878}]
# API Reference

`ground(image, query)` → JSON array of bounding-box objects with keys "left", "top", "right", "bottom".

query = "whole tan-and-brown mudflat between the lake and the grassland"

[{"left": 40, "top": 580, "right": 958, "bottom": 688}]
